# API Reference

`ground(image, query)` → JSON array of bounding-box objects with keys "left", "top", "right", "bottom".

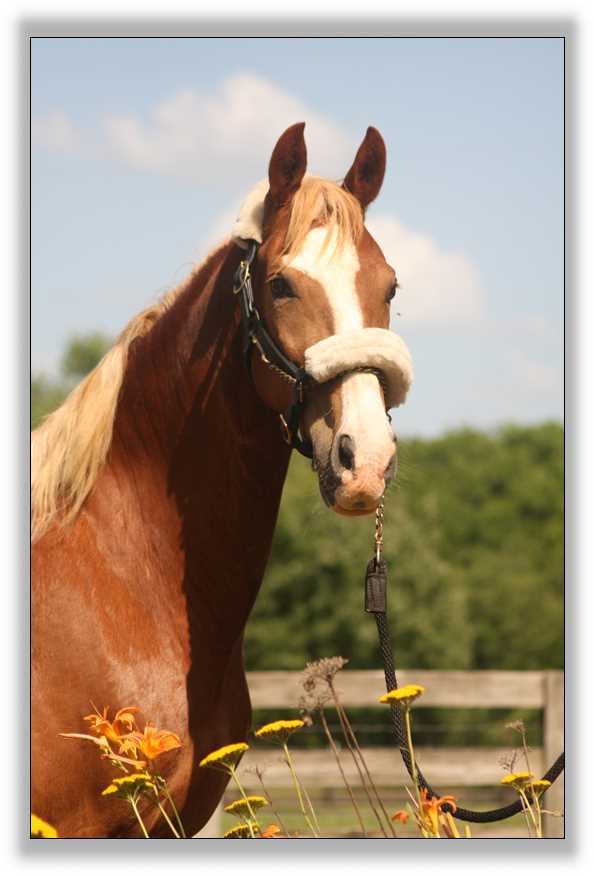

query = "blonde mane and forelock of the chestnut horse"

[{"left": 31, "top": 176, "right": 363, "bottom": 541}]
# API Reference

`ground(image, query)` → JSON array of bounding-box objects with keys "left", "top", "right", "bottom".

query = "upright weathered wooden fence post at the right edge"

[{"left": 543, "top": 670, "right": 565, "bottom": 839}]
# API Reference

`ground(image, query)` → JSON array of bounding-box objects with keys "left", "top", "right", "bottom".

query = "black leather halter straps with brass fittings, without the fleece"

[{"left": 233, "top": 240, "right": 313, "bottom": 459}]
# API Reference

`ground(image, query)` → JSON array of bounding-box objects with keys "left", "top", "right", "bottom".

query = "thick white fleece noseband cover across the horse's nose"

[{"left": 305, "top": 328, "right": 413, "bottom": 408}]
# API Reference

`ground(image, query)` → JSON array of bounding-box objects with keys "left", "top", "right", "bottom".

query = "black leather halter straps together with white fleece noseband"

[{"left": 233, "top": 240, "right": 413, "bottom": 459}]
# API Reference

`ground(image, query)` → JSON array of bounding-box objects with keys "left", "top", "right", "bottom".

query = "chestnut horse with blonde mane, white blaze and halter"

[{"left": 31, "top": 123, "right": 412, "bottom": 837}]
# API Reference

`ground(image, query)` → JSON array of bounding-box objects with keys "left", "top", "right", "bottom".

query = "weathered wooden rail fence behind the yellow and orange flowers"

[{"left": 198, "top": 669, "right": 564, "bottom": 837}]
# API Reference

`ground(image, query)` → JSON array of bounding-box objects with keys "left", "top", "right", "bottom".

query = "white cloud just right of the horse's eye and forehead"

[{"left": 367, "top": 215, "right": 487, "bottom": 328}]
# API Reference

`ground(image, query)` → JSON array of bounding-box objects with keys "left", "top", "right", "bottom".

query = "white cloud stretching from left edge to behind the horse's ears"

[{"left": 36, "top": 73, "right": 352, "bottom": 185}]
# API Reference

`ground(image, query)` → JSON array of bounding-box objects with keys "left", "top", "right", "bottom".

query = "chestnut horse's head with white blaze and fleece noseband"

[{"left": 232, "top": 124, "right": 412, "bottom": 515}]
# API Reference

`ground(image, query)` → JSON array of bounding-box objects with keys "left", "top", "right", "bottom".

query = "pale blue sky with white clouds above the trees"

[{"left": 31, "top": 38, "right": 564, "bottom": 436}]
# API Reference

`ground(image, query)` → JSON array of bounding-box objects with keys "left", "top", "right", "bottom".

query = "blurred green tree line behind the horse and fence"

[{"left": 31, "top": 334, "right": 564, "bottom": 669}]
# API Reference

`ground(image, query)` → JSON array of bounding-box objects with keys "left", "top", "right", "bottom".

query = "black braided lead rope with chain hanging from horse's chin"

[{"left": 365, "top": 499, "right": 565, "bottom": 822}]
